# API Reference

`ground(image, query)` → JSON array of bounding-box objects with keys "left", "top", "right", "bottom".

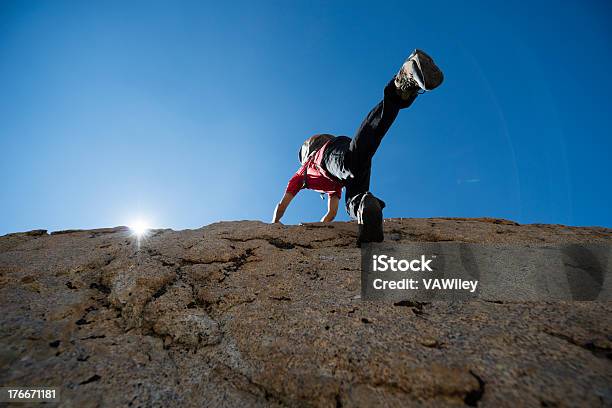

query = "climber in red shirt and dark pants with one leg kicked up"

[{"left": 272, "top": 49, "right": 444, "bottom": 245}]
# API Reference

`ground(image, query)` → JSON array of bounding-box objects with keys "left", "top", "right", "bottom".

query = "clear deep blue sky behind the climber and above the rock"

[{"left": 0, "top": 0, "right": 612, "bottom": 234}]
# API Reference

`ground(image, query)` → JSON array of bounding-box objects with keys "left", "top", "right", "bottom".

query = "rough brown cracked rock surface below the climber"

[{"left": 0, "top": 219, "right": 612, "bottom": 407}]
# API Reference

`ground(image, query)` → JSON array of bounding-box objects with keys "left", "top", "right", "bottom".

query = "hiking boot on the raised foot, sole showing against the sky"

[{"left": 394, "top": 49, "right": 444, "bottom": 99}]
